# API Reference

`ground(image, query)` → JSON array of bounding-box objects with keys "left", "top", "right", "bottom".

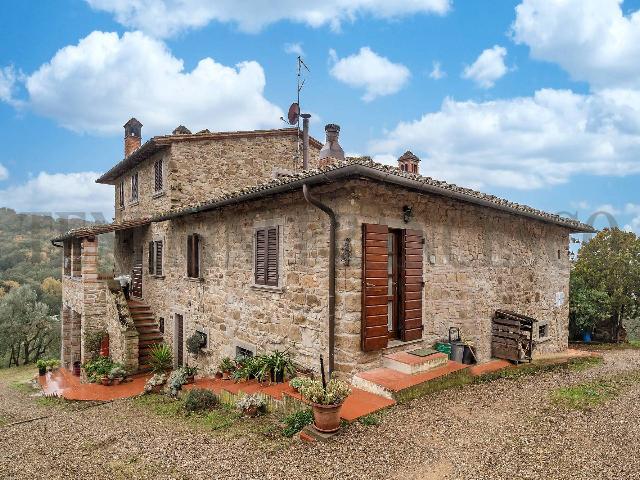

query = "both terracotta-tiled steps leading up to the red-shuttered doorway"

[{"left": 352, "top": 352, "right": 468, "bottom": 400}]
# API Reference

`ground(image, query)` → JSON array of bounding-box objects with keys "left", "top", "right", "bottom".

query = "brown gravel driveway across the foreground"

[{"left": 0, "top": 350, "right": 640, "bottom": 480}]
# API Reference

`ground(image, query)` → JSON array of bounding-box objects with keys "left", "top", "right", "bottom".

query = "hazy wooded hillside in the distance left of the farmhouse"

[{"left": 0, "top": 208, "right": 113, "bottom": 298}]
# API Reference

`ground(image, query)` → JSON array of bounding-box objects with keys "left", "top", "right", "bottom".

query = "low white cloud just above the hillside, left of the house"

[{"left": 0, "top": 172, "right": 114, "bottom": 221}]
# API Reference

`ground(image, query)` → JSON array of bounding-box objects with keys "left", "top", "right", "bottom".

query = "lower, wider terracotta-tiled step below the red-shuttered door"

[{"left": 353, "top": 360, "right": 468, "bottom": 399}]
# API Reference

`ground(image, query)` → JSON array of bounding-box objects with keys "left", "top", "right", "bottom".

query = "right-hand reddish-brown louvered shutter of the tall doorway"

[{"left": 398, "top": 230, "right": 424, "bottom": 342}]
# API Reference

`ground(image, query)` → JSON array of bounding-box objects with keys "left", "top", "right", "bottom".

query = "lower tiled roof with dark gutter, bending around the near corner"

[{"left": 55, "top": 157, "right": 595, "bottom": 241}]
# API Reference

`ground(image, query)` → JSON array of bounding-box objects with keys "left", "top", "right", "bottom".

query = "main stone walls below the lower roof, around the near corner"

[{"left": 111, "top": 180, "right": 569, "bottom": 375}]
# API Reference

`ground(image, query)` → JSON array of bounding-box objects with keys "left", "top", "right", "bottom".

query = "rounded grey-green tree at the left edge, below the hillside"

[{"left": 0, "top": 285, "right": 60, "bottom": 366}]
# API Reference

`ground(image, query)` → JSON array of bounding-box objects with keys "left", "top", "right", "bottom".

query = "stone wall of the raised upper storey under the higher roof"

[{"left": 114, "top": 131, "right": 320, "bottom": 221}]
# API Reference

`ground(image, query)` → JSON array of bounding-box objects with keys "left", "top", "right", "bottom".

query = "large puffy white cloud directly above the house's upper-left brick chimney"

[{"left": 5, "top": 32, "right": 282, "bottom": 134}]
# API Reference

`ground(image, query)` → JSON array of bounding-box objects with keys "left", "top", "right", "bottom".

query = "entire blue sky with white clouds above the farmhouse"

[{"left": 0, "top": 0, "right": 640, "bottom": 233}]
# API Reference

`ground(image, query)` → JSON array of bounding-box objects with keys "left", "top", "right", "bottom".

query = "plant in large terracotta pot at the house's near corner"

[{"left": 300, "top": 379, "right": 351, "bottom": 433}]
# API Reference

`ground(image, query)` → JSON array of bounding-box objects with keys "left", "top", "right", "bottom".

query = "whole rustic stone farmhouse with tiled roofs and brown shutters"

[{"left": 53, "top": 118, "right": 593, "bottom": 377}]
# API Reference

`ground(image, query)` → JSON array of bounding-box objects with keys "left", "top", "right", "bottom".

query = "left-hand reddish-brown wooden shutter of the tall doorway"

[{"left": 361, "top": 223, "right": 389, "bottom": 352}]
